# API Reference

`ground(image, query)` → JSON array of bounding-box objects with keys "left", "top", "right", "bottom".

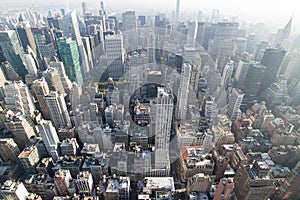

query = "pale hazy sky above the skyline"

[{"left": 0, "top": 0, "right": 300, "bottom": 33}]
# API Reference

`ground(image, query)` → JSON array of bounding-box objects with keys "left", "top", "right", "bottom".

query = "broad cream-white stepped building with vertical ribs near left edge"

[{"left": 4, "top": 81, "right": 35, "bottom": 116}]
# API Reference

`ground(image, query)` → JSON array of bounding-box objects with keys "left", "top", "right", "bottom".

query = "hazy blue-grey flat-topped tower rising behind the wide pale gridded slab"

[{"left": 122, "top": 11, "right": 138, "bottom": 50}]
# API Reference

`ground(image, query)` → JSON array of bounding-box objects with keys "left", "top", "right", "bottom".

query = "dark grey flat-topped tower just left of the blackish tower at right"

[{"left": 243, "top": 63, "right": 266, "bottom": 109}]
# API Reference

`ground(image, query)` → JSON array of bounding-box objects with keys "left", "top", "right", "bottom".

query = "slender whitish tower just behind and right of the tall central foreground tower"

[{"left": 176, "top": 63, "right": 192, "bottom": 120}]
